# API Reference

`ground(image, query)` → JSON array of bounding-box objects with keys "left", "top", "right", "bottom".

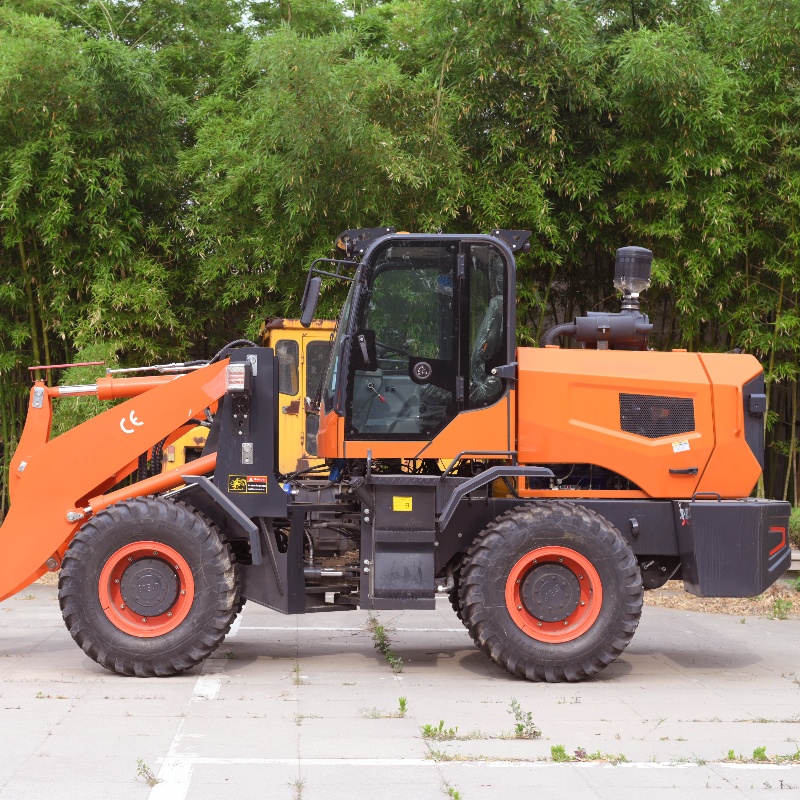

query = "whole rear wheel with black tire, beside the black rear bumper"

[{"left": 460, "top": 501, "right": 643, "bottom": 682}]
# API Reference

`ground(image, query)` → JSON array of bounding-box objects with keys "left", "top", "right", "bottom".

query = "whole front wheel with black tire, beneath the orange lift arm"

[{"left": 59, "top": 497, "right": 240, "bottom": 677}]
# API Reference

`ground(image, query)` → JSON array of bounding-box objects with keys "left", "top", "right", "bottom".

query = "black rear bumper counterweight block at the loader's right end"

[{"left": 673, "top": 499, "right": 792, "bottom": 597}]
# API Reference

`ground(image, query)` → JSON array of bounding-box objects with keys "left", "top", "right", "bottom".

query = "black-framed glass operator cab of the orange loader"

[{"left": 310, "top": 228, "right": 527, "bottom": 455}]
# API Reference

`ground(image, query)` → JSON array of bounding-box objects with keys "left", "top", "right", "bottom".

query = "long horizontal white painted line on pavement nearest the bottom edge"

[{"left": 155, "top": 755, "right": 800, "bottom": 772}]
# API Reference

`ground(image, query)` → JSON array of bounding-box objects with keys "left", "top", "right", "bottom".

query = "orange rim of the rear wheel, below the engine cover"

[{"left": 505, "top": 547, "right": 603, "bottom": 643}]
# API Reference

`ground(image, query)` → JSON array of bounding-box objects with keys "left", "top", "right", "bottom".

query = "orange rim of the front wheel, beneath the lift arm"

[{"left": 97, "top": 541, "right": 194, "bottom": 638}]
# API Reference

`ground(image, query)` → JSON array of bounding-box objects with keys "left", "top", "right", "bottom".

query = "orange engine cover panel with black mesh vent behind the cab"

[{"left": 517, "top": 348, "right": 761, "bottom": 498}]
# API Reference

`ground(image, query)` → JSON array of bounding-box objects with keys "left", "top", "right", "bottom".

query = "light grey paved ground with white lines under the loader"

[{"left": 0, "top": 585, "right": 800, "bottom": 800}]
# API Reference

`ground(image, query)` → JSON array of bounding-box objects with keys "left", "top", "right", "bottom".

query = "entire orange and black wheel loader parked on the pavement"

[{"left": 0, "top": 227, "right": 790, "bottom": 681}]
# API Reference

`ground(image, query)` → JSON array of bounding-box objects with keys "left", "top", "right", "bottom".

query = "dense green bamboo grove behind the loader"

[{"left": 0, "top": 0, "right": 800, "bottom": 516}]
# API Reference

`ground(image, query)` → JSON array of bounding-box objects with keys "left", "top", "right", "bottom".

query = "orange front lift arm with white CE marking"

[{"left": 0, "top": 359, "right": 228, "bottom": 600}]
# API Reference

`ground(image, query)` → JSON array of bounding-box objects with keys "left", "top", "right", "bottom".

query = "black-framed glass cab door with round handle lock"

[{"left": 346, "top": 239, "right": 464, "bottom": 441}]
